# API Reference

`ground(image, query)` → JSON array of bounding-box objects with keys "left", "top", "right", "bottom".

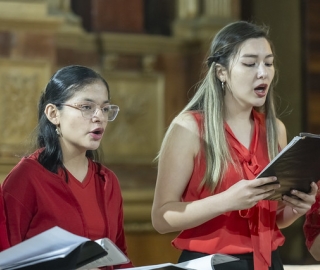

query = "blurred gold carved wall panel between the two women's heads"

[{"left": 102, "top": 72, "right": 164, "bottom": 164}]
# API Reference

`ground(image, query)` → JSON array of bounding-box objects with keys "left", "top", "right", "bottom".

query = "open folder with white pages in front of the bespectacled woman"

[{"left": 0, "top": 227, "right": 129, "bottom": 270}]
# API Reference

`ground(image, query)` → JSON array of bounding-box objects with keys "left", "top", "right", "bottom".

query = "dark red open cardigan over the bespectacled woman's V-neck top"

[{"left": 2, "top": 153, "right": 133, "bottom": 270}]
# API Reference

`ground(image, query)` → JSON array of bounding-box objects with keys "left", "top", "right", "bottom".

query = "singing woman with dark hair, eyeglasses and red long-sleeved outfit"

[{"left": 2, "top": 66, "right": 132, "bottom": 269}]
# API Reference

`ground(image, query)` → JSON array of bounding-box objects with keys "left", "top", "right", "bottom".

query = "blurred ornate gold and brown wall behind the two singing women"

[{"left": 0, "top": 0, "right": 320, "bottom": 266}]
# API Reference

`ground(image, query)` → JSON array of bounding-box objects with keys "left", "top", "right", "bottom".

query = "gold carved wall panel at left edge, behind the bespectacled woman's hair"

[{"left": 0, "top": 59, "right": 50, "bottom": 157}]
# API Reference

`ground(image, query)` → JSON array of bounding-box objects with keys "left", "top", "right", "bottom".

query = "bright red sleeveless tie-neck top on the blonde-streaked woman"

[{"left": 172, "top": 110, "right": 284, "bottom": 270}]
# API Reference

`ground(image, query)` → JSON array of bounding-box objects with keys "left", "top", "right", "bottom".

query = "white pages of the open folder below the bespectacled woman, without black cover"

[{"left": 0, "top": 227, "right": 129, "bottom": 270}]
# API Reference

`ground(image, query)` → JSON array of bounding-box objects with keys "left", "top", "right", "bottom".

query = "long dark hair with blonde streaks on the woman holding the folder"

[{"left": 159, "top": 21, "right": 279, "bottom": 191}]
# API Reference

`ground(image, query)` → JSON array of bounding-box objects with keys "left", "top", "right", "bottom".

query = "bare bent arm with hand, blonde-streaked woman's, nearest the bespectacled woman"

[{"left": 152, "top": 114, "right": 279, "bottom": 233}]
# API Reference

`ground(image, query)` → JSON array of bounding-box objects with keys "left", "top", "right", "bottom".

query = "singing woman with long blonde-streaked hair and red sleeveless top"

[{"left": 152, "top": 21, "right": 317, "bottom": 270}]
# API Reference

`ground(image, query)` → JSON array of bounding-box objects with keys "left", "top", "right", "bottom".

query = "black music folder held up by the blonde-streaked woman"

[{"left": 256, "top": 133, "right": 320, "bottom": 200}]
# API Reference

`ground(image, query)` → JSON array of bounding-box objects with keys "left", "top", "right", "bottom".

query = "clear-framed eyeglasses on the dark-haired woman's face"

[{"left": 60, "top": 101, "right": 120, "bottom": 121}]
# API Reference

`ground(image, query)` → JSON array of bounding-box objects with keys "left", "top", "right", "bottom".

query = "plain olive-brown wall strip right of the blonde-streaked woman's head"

[{"left": 252, "top": 0, "right": 306, "bottom": 140}]
